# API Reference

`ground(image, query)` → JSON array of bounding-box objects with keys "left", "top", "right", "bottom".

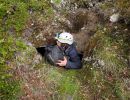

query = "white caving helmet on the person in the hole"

[{"left": 55, "top": 32, "right": 74, "bottom": 45}]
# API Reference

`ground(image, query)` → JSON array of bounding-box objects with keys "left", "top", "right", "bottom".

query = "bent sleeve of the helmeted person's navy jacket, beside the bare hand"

[{"left": 65, "top": 52, "right": 82, "bottom": 69}]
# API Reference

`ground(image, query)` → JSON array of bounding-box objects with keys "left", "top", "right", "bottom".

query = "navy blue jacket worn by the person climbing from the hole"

[{"left": 64, "top": 44, "right": 82, "bottom": 69}]
